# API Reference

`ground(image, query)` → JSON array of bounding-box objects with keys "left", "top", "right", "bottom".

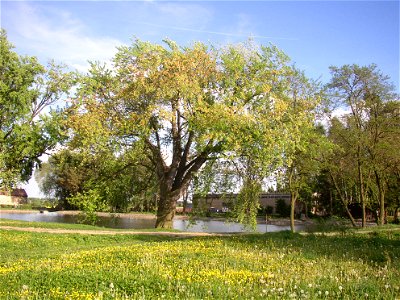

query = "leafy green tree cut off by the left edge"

[{"left": 0, "top": 30, "right": 72, "bottom": 189}]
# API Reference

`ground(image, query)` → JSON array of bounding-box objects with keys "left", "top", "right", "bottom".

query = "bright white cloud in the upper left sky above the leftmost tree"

[{"left": 3, "top": 2, "right": 122, "bottom": 71}]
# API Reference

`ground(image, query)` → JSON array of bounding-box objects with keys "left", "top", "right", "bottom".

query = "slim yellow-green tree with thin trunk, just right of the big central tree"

[{"left": 276, "top": 69, "right": 328, "bottom": 232}]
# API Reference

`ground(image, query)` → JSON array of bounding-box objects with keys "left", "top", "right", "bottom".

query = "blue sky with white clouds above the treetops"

[{"left": 0, "top": 0, "right": 400, "bottom": 194}]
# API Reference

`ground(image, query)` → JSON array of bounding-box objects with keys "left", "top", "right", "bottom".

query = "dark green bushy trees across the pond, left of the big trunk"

[{"left": 35, "top": 149, "right": 156, "bottom": 212}]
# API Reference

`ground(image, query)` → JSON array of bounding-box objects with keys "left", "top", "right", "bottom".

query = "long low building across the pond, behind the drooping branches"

[{"left": 193, "top": 193, "right": 302, "bottom": 214}]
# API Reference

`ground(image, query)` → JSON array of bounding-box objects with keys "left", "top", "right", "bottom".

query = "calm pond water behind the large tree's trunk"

[{"left": 0, "top": 212, "right": 304, "bottom": 233}]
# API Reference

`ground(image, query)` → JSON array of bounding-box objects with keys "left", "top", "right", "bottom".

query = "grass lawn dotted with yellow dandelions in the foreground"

[{"left": 0, "top": 220, "right": 400, "bottom": 299}]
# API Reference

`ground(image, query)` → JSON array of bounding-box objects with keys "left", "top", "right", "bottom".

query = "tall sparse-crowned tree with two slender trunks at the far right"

[{"left": 329, "top": 65, "right": 398, "bottom": 226}]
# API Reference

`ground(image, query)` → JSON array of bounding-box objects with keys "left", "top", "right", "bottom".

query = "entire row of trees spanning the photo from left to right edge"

[{"left": 0, "top": 30, "right": 400, "bottom": 230}]
